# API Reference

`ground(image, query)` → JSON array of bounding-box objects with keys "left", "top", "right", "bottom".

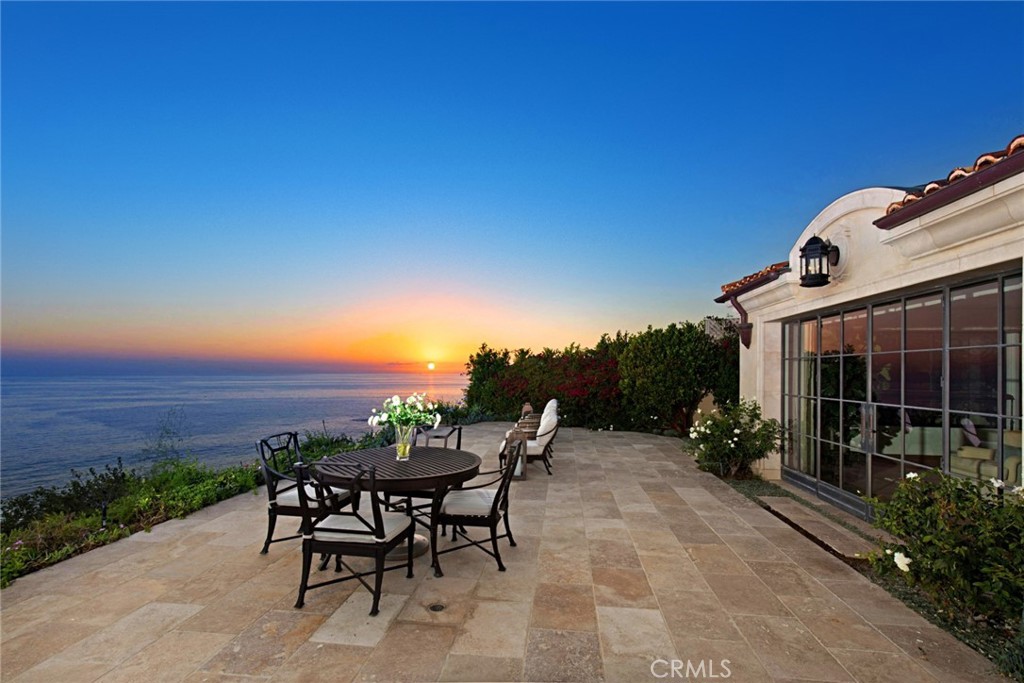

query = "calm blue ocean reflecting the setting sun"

[{"left": 0, "top": 373, "right": 467, "bottom": 497}]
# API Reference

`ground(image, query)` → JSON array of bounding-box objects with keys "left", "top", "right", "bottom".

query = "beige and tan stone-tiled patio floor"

[{"left": 0, "top": 423, "right": 1006, "bottom": 683}]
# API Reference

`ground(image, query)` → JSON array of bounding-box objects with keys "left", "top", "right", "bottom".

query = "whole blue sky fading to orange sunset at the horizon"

[{"left": 0, "top": 2, "right": 1024, "bottom": 371}]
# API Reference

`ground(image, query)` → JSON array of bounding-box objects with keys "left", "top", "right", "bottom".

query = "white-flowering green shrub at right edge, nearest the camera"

[{"left": 869, "top": 472, "right": 1024, "bottom": 630}]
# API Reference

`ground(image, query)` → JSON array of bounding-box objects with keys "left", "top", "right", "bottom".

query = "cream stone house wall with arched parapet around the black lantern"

[{"left": 738, "top": 179, "right": 1024, "bottom": 479}]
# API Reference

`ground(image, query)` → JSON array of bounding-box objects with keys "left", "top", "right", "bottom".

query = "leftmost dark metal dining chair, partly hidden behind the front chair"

[{"left": 256, "top": 432, "right": 348, "bottom": 555}]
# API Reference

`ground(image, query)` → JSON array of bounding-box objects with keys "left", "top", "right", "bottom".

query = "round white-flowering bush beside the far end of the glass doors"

[{"left": 690, "top": 397, "right": 781, "bottom": 477}]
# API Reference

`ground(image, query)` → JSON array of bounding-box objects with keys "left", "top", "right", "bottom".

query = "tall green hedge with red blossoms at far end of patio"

[{"left": 466, "top": 323, "right": 739, "bottom": 434}]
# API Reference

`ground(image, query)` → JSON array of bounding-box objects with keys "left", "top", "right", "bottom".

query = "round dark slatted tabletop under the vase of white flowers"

[{"left": 313, "top": 445, "right": 480, "bottom": 492}]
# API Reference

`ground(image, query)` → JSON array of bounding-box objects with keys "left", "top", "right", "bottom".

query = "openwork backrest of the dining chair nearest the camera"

[{"left": 295, "top": 462, "right": 386, "bottom": 541}]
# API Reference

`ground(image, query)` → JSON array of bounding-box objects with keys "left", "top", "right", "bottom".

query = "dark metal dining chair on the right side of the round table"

[{"left": 430, "top": 441, "right": 522, "bottom": 577}]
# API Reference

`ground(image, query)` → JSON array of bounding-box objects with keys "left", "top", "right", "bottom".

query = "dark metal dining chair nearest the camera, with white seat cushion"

[{"left": 295, "top": 463, "right": 415, "bottom": 616}]
